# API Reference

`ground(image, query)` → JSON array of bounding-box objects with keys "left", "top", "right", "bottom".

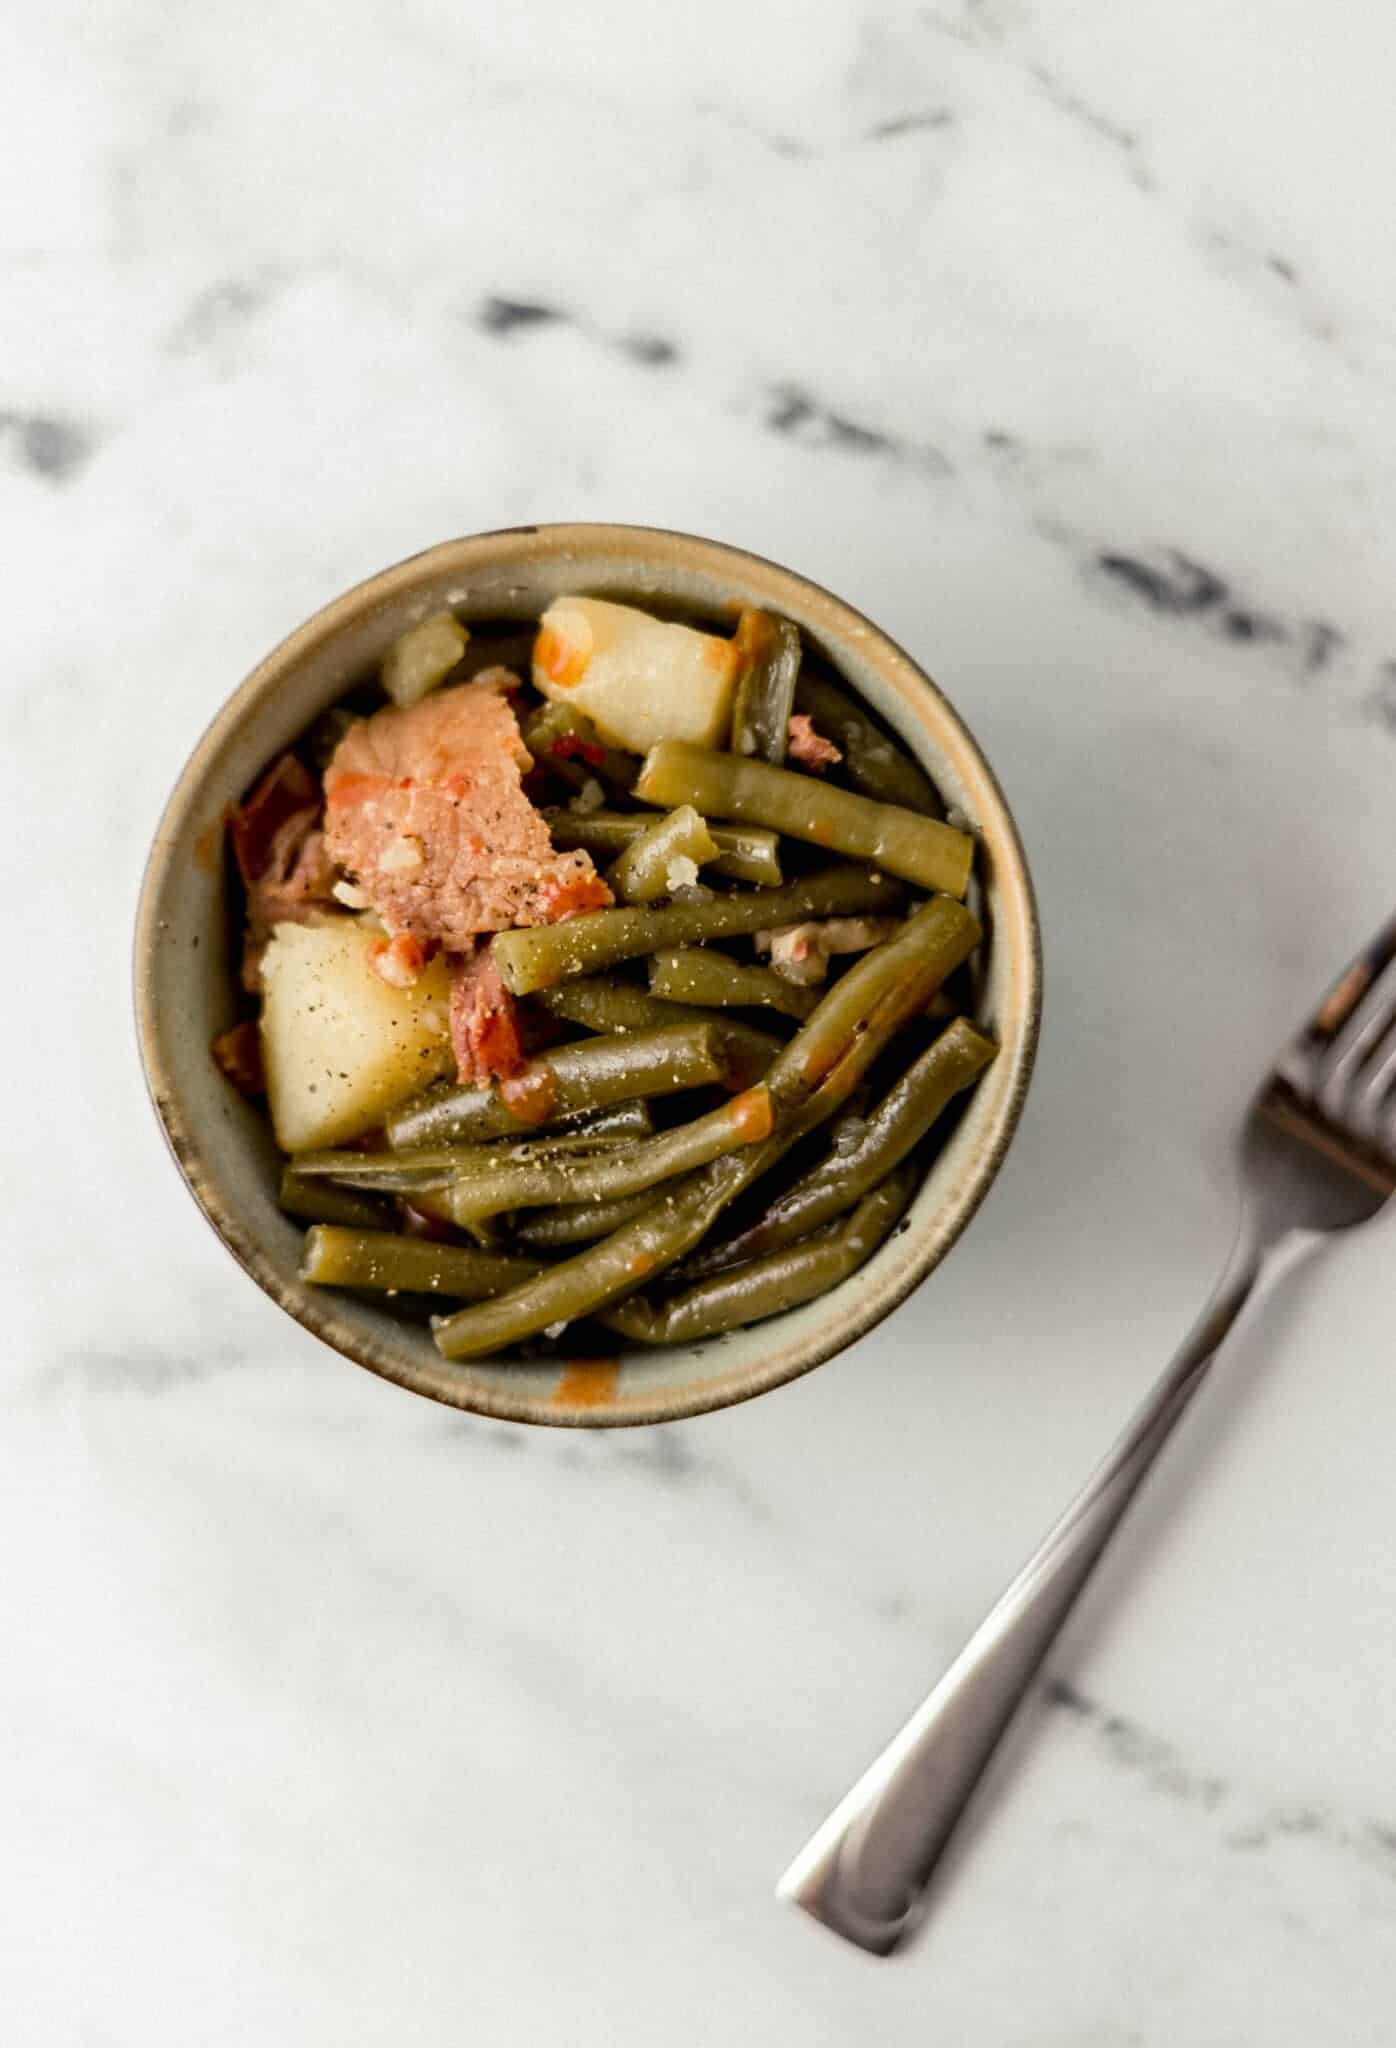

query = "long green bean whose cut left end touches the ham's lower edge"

[{"left": 493, "top": 864, "right": 900, "bottom": 995}]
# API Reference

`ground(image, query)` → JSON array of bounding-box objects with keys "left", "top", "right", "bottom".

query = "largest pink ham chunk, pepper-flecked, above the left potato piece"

[{"left": 325, "top": 672, "right": 610, "bottom": 952}]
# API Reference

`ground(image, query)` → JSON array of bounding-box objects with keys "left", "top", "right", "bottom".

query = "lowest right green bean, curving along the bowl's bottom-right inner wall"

[{"left": 604, "top": 1171, "right": 915, "bottom": 1343}]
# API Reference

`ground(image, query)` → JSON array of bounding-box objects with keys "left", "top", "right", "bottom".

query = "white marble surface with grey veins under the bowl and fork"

[{"left": 0, "top": 0, "right": 1396, "bottom": 2048}]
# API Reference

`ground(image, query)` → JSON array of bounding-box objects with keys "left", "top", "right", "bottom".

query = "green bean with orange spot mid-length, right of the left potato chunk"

[{"left": 387, "top": 1024, "right": 733, "bottom": 1147}]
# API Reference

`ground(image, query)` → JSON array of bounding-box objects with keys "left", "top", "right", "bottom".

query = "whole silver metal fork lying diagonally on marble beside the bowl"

[{"left": 776, "top": 918, "right": 1396, "bottom": 1956}]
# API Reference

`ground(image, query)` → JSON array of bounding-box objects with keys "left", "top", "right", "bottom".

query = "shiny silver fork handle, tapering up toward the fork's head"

[{"left": 778, "top": 1227, "right": 1267, "bottom": 1956}]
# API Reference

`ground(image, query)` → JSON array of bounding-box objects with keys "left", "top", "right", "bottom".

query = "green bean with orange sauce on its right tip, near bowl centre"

[{"left": 446, "top": 1083, "right": 772, "bottom": 1223}]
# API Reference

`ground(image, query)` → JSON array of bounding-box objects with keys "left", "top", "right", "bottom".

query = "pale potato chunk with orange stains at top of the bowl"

[{"left": 532, "top": 598, "right": 737, "bottom": 754}]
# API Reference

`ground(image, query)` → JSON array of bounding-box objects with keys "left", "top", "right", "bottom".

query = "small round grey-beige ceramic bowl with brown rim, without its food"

[{"left": 135, "top": 526, "right": 1042, "bottom": 1425}]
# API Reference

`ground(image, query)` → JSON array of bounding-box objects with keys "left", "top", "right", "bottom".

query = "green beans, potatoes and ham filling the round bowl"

[{"left": 215, "top": 594, "right": 997, "bottom": 1358}]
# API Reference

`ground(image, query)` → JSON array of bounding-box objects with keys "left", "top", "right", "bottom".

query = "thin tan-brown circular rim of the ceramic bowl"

[{"left": 131, "top": 520, "right": 1042, "bottom": 1427}]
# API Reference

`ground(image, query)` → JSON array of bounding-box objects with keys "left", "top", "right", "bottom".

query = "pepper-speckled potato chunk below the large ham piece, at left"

[{"left": 262, "top": 918, "right": 454, "bottom": 1153}]
